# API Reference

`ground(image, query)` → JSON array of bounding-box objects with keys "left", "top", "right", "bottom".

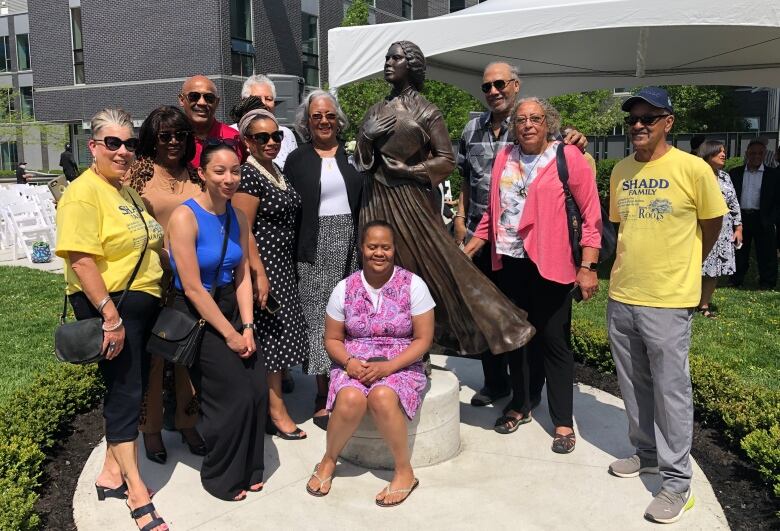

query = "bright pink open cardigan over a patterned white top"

[{"left": 474, "top": 144, "right": 601, "bottom": 284}]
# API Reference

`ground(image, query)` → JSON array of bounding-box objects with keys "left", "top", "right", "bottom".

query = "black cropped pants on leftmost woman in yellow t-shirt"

[{"left": 70, "top": 291, "right": 160, "bottom": 443}]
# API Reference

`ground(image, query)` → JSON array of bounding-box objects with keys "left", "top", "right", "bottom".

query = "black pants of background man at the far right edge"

[{"left": 732, "top": 210, "right": 777, "bottom": 287}]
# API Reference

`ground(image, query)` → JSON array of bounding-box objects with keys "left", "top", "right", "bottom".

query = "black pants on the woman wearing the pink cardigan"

[{"left": 498, "top": 256, "right": 574, "bottom": 428}]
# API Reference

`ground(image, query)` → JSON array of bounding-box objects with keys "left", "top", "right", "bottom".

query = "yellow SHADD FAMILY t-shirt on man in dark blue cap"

[{"left": 609, "top": 148, "right": 728, "bottom": 308}]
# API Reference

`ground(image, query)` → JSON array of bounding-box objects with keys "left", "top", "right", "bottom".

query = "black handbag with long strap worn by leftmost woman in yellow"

[{"left": 54, "top": 196, "right": 149, "bottom": 365}]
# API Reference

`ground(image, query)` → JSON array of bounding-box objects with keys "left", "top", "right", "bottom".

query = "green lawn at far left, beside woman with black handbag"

[{"left": 0, "top": 267, "right": 65, "bottom": 402}]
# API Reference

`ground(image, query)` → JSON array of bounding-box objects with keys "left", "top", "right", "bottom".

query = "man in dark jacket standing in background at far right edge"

[{"left": 730, "top": 139, "right": 780, "bottom": 289}]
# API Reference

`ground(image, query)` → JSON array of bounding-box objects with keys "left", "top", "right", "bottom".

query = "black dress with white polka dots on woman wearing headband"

[{"left": 238, "top": 164, "right": 309, "bottom": 372}]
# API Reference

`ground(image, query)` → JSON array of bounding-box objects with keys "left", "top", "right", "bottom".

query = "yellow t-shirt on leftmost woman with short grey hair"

[{"left": 57, "top": 169, "right": 163, "bottom": 297}]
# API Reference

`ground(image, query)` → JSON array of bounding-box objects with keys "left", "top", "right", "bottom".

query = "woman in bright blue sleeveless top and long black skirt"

[{"left": 167, "top": 143, "right": 268, "bottom": 500}]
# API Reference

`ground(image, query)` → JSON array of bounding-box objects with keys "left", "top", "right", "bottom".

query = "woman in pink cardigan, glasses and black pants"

[{"left": 464, "top": 98, "right": 601, "bottom": 453}]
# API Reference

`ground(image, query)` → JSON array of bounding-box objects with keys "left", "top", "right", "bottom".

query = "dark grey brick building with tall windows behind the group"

[{"left": 27, "top": 0, "right": 478, "bottom": 167}]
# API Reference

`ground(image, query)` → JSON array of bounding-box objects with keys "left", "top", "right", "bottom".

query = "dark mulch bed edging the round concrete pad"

[{"left": 36, "top": 363, "right": 780, "bottom": 531}]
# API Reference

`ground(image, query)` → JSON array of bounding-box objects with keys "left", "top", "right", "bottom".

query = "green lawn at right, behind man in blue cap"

[{"left": 573, "top": 278, "right": 780, "bottom": 390}]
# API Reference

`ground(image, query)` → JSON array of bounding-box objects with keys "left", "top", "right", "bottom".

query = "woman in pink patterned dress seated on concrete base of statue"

[{"left": 306, "top": 220, "right": 435, "bottom": 507}]
